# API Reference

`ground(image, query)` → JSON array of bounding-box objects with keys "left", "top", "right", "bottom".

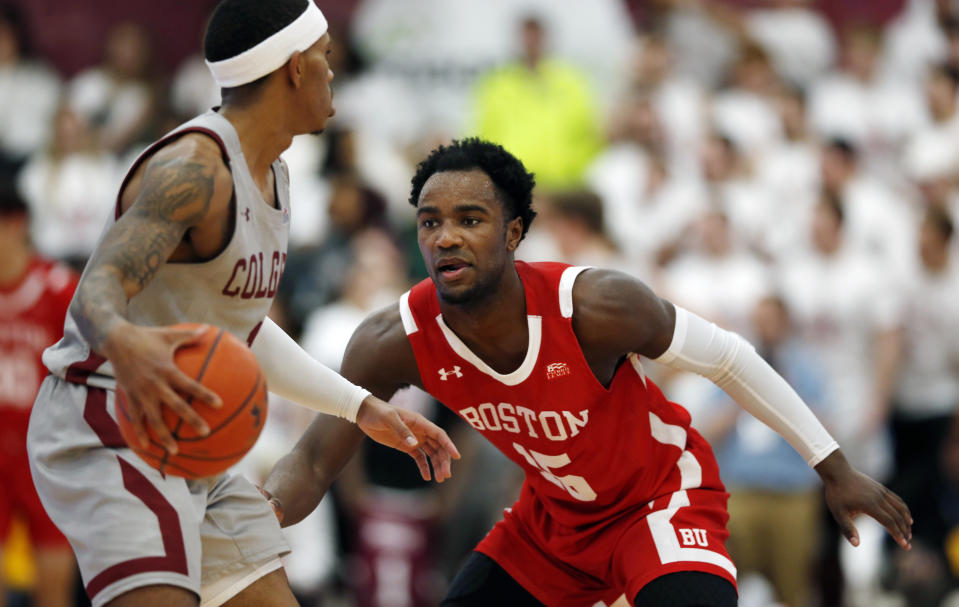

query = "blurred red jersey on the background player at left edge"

[{"left": 0, "top": 258, "right": 77, "bottom": 457}]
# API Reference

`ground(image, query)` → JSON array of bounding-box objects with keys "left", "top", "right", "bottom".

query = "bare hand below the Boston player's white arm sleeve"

[{"left": 816, "top": 450, "right": 912, "bottom": 550}]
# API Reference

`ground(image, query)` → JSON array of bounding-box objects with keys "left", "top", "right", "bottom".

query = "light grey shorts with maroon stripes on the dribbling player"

[{"left": 27, "top": 376, "right": 289, "bottom": 607}]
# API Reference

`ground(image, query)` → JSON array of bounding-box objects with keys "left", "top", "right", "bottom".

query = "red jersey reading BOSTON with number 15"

[{"left": 400, "top": 262, "right": 722, "bottom": 527}]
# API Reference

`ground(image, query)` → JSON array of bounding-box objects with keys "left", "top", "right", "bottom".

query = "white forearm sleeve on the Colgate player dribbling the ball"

[{"left": 252, "top": 318, "right": 370, "bottom": 423}]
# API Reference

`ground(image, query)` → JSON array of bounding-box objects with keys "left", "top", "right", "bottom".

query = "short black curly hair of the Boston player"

[{"left": 410, "top": 137, "right": 536, "bottom": 237}]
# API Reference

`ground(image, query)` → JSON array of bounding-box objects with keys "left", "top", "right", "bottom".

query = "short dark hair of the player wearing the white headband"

[{"left": 203, "top": 0, "right": 310, "bottom": 97}]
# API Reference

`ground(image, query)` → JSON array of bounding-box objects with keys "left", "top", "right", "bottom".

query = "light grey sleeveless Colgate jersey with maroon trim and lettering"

[{"left": 43, "top": 110, "right": 290, "bottom": 389}]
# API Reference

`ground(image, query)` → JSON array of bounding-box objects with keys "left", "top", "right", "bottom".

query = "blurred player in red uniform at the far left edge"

[{"left": 0, "top": 183, "right": 78, "bottom": 607}]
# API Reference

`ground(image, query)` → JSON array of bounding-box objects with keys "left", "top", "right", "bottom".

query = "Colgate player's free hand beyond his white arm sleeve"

[{"left": 356, "top": 396, "right": 460, "bottom": 483}]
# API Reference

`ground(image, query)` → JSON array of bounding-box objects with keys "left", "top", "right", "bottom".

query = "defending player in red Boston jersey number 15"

[{"left": 265, "top": 139, "right": 911, "bottom": 607}]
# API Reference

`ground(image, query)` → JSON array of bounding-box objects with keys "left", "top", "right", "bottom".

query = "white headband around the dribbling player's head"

[{"left": 206, "top": 0, "right": 327, "bottom": 88}]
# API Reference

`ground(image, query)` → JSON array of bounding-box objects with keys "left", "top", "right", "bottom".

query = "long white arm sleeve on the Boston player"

[{"left": 655, "top": 306, "right": 839, "bottom": 466}]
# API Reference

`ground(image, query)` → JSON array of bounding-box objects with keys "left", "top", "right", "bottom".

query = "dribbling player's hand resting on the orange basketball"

[{"left": 103, "top": 324, "right": 223, "bottom": 453}]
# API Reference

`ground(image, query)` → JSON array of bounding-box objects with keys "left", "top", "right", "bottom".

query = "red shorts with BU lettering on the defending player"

[{"left": 476, "top": 452, "right": 736, "bottom": 607}]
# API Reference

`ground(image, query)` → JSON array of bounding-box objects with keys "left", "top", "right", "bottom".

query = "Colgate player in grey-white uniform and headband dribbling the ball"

[{"left": 22, "top": 0, "right": 458, "bottom": 607}]
